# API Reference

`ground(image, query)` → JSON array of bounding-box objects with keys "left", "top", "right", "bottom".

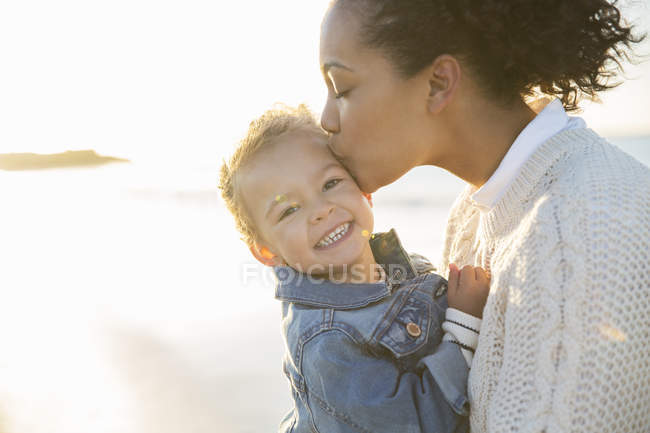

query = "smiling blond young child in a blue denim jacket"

[{"left": 220, "top": 106, "right": 489, "bottom": 433}]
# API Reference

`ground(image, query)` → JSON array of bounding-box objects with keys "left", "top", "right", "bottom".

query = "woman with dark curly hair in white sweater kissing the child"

[{"left": 321, "top": 0, "right": 650, "bottom": 433}]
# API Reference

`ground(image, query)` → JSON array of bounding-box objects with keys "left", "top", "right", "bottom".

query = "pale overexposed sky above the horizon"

[{"left": 0, "top": 0, "right": 650, "bottom": 166}]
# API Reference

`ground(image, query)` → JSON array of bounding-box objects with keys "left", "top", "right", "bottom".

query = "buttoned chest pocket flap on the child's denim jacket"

[{"left": 376, "top": 296, "right": 431, "bottom": 358}]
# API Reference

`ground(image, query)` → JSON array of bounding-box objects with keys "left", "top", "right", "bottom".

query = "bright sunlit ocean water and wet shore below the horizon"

[{"left": 0, "top": 137, "right": 650, "bottom": 433}]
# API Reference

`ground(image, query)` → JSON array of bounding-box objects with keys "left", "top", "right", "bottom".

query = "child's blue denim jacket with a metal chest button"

[{"left": 274, "top": 230, "right": 468, "bottom": 433}]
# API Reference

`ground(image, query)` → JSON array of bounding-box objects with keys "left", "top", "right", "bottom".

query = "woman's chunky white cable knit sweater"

[{"left": 440, "top": 129, "right": 650, "bottom": 433}]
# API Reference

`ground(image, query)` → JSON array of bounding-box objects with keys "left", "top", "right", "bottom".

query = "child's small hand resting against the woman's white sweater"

[{"left": 447, "top": 263, "right": 490, "bottom": 318}]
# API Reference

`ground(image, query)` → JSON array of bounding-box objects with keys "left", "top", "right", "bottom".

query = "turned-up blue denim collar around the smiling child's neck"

[{"left": 273, "top": 229, "right": 417, "bottom": 309}]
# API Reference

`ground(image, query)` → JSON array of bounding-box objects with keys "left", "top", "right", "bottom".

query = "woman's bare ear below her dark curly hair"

[{"left": 427, "top": 54, "right": 461, "bottom": 114}]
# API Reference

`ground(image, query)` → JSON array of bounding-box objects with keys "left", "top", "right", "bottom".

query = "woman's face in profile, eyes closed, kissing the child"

[{"left": 320, "top": 7, "right": 429, "bottom": 193}]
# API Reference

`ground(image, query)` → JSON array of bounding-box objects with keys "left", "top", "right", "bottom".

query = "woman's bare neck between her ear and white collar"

[{"left": 433, "top": 98, "right": 536, "bottom": 188}]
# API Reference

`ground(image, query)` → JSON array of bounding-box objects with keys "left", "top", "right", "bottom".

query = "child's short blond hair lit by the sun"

[{"left": 219, "top": 104, "right": 325, "bottom": 246}]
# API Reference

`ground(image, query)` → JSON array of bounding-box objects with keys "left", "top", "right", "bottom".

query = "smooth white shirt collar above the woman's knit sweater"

[{"left": 471, "top": 99, "right": 586, "bottom": 212}]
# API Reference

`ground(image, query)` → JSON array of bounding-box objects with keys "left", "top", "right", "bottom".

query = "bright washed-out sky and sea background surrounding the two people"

[{"left": 0, "top": 0, "right": 650, "bottom": 433}]
